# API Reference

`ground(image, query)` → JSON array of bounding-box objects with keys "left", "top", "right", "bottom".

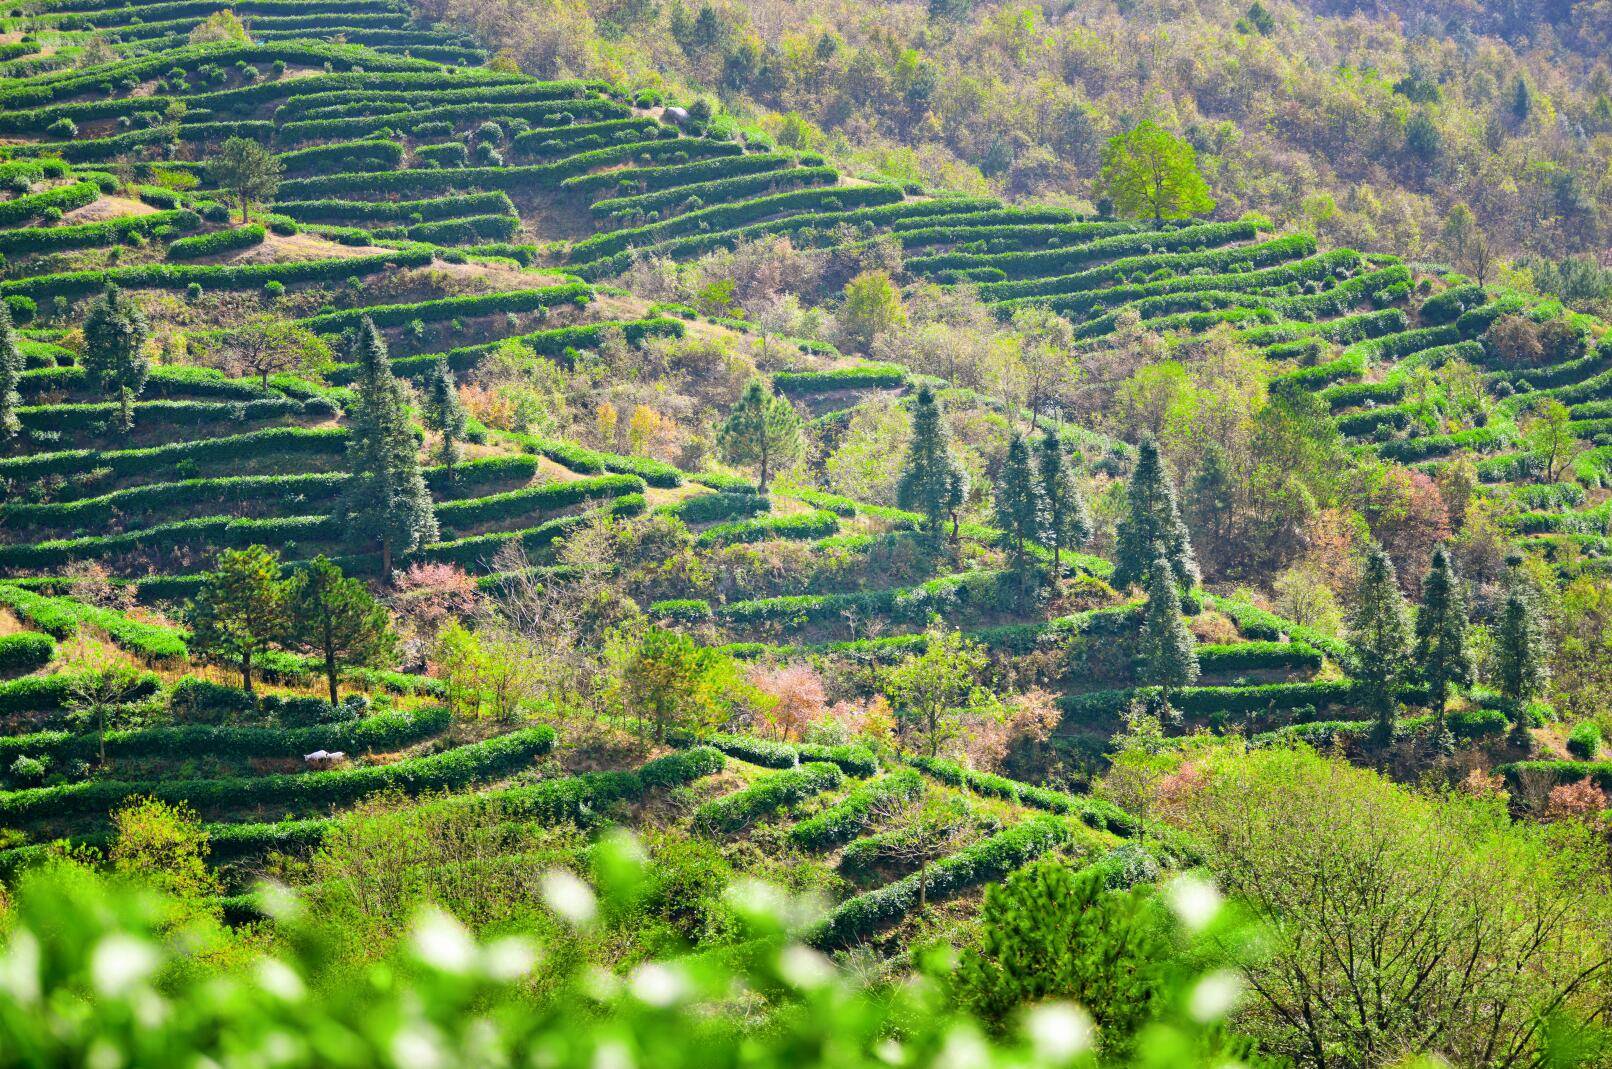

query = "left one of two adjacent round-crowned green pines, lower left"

[{"left": 190, "top": 545, "right": 287, "bottom": 693}]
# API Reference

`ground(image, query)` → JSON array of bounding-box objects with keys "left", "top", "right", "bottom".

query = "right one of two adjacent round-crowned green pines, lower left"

[{"left": 289, "top": 556, "right": 395, "bottom": 705}]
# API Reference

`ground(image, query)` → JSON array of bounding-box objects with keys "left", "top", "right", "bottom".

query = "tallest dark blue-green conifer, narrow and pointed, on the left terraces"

[{"left": 342, "top": 316, "right": 437, "bottom": 582}]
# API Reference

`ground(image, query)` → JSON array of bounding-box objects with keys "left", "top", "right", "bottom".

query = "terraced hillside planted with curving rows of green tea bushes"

[{"left": 0, "top": 0, "right": 1612, "bottom": 946}]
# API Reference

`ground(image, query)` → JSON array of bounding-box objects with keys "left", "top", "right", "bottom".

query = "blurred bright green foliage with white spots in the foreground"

[{"left": 0, "top": 835, "right": 1238, "bottom": 1069}]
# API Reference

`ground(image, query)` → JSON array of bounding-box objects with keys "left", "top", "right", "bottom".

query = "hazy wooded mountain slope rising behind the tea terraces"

[{"left": 421, "top": 0, "right": 1612, "bottom": 303}]
